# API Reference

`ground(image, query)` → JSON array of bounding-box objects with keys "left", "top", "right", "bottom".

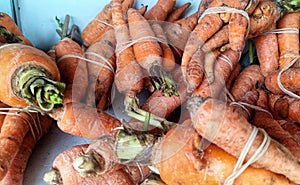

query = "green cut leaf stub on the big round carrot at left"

[{"left": 12, "top": 64, "right": 65, "bottom": 111}]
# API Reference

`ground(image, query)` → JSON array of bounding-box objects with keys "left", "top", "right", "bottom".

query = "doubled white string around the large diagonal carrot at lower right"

[{"left": 224, "top": 127, "right": 271, "bottom": 185}]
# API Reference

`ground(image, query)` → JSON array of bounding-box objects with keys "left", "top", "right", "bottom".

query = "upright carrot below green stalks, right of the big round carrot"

[{"left": 55, "top": 38, "right": 88, "bottom": 103}]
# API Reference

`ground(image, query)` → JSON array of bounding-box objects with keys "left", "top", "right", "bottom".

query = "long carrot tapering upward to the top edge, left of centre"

[{"left": 112, "top": 2, "right": 144, "bottom": 93}]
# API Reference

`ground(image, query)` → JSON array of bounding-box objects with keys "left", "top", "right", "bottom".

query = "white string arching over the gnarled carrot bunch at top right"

[{"left": 198, "top": 6, "right": 250, "bottom": 37}]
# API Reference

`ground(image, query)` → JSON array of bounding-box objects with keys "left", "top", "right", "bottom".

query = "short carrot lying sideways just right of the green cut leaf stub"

[{"left": 50, "top": 102, "right": 121, "bottom": 139}]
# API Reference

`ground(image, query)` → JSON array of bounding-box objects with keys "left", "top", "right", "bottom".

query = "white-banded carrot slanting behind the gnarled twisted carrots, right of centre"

[{"left": 192, "top": 50, "right": 240, "bottom": 97}]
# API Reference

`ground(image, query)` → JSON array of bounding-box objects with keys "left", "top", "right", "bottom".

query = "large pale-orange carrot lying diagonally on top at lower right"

[{"left": 190, "top": 98, "right": 300, "bottom": 183}]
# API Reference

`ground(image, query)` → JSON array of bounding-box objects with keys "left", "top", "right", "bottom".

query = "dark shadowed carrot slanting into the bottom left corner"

[{"left": 0, "top": 115, "right": 53, "bottom": 185}]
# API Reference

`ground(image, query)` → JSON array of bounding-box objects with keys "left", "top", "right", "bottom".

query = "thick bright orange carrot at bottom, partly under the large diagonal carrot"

[{"left": 155, "top": 120, "right": 293, "bottom": 185}]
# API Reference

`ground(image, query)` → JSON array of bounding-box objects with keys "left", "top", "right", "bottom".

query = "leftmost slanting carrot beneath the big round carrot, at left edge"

[{"left": 0, "top": 110, "right": 40, "bottom": 180}]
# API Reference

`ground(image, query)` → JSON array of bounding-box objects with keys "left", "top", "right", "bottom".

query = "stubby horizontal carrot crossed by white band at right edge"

[{"left": 265, "top": 68, "right": 300, "bottom": 94}]
